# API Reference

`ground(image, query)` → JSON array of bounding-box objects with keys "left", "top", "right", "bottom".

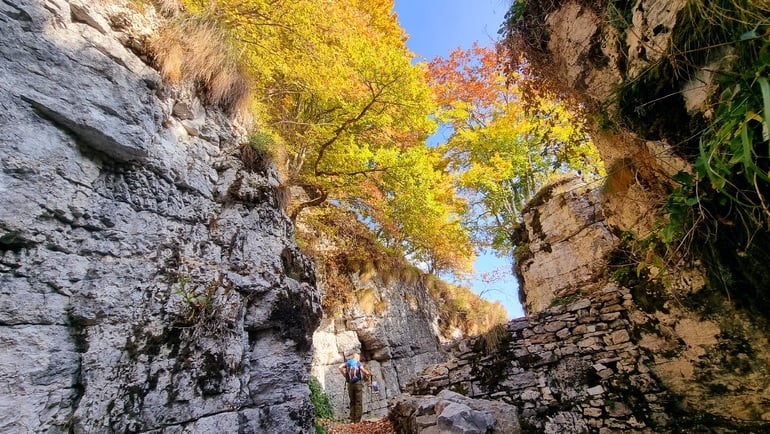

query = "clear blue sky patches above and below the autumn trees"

[{"left": 395, "top": 0, "right": 524, "bottom": 318}]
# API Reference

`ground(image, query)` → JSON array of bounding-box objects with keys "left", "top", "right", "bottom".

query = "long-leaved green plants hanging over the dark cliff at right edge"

[{"left": 614, "top": 0, "right": 770, "bottom": 306}]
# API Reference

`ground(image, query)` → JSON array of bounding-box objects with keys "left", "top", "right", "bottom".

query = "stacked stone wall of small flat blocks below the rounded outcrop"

[{"left": 408, "top": 285, "right": 676, "bottom": 433}]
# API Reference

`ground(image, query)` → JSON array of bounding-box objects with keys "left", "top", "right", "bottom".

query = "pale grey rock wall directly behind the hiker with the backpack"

[{"left": 311, "top": 273, "right": 446, "bottom": 419}]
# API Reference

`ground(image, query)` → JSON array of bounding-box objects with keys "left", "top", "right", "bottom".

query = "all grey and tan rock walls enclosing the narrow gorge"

[{"left": 0, "top": 0, "right": 770, "bottom": 434}]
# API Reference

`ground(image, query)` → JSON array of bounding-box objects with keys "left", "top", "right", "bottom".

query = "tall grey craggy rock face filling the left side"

[{"left": 0, "top": 0, "right": 321, "bottom": 433}]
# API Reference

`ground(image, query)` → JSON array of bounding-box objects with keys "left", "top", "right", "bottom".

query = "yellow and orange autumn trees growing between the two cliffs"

[{"left": 140, "top": 0, "right": 601, "bottom": 328}]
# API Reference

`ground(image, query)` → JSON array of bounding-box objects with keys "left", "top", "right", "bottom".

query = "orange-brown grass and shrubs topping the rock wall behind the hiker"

[{"left": 297, "top": 205, "right": 507, "bottom": 338}]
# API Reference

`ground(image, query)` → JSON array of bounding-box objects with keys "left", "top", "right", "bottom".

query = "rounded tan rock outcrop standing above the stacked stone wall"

[{"left": 514, "top": 178, "right": 615, "bottom": 314}]
